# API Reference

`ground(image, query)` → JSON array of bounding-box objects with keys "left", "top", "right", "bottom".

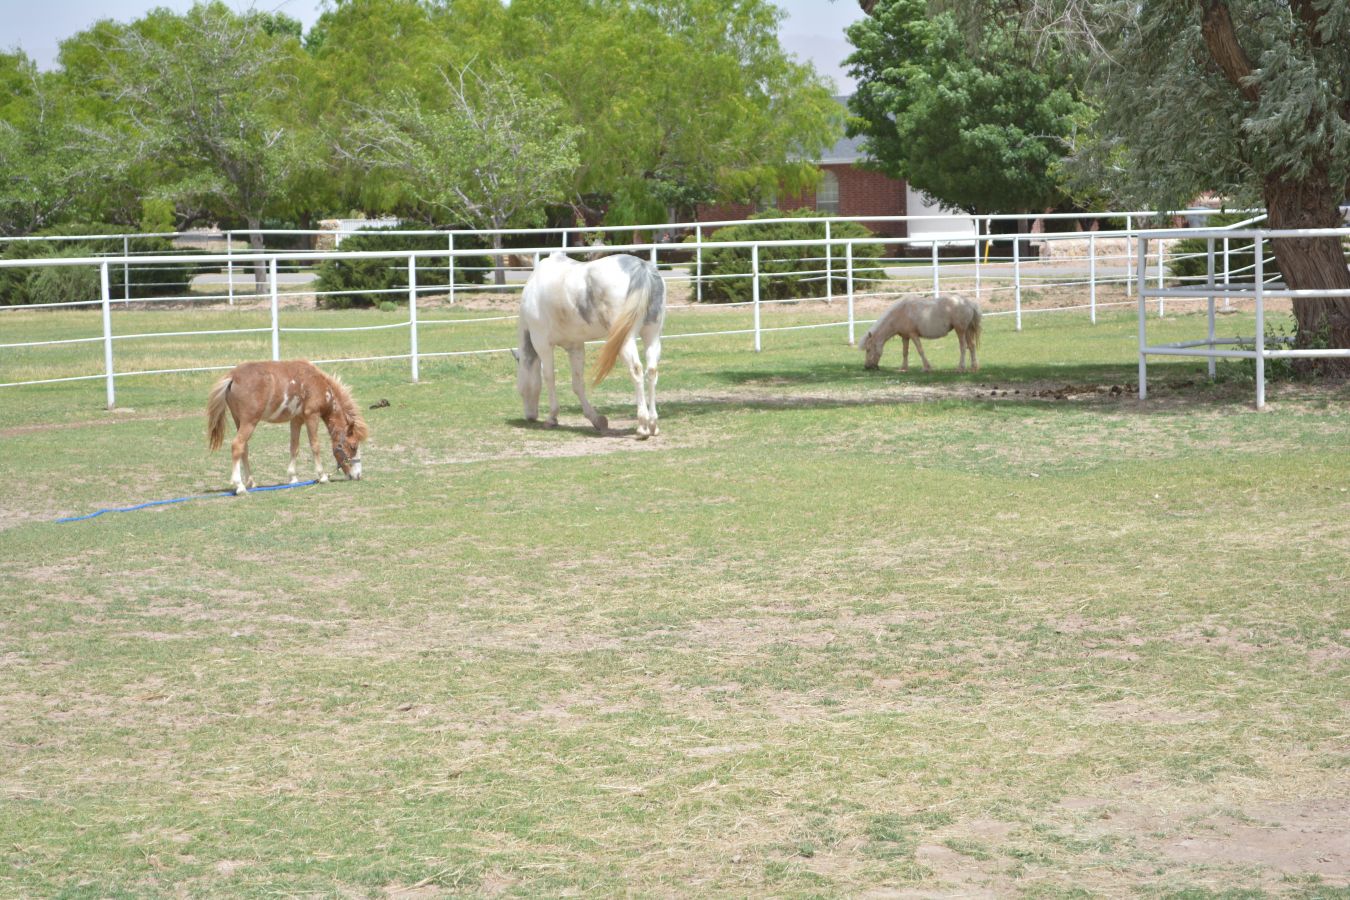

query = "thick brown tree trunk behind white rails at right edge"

[{"left": 1265, "top": 166, "right": 1350, "bottom": 375}]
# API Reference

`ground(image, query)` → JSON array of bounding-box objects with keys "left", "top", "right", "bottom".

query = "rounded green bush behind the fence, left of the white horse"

[{"left": 315, "top": 228, "right": 491, "bottom": 309}]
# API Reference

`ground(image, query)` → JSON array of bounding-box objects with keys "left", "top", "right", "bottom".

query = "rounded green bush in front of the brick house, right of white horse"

[{"left": 703, "top": 209, "right": 884, "bottom": 304}]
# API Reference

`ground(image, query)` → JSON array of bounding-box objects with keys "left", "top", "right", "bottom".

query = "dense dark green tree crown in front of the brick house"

[{"left": 848, "top": 0, "right": 1088, "bottom": 213}]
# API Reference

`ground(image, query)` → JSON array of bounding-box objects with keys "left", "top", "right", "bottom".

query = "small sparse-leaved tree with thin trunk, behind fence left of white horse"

[{"left": 344, "top": 70, "right": 579, "bottom": 283}]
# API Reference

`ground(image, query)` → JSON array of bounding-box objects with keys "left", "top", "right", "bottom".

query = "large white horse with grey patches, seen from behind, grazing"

[{"left": 516, "top": 251, "right": 666, "bottom": 440}]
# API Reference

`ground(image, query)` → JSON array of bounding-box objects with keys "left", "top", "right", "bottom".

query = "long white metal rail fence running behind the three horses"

[{"left": 0, "top": 207, "right": 1317, "bottom": 409}]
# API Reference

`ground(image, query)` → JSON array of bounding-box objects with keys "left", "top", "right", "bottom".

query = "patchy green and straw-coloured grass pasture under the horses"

[{"left": 0, "top": 299, "right": 1350, "bottom": 897}]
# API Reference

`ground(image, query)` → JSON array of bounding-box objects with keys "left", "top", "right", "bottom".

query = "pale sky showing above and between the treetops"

[{"left": 0, "top": 0, "right": 863, "bottom": 93}]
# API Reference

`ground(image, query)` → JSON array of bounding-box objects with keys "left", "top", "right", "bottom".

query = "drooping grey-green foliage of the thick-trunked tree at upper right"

[{"left": 1088, "top": 0, "right": 1350, "bottom": 215}]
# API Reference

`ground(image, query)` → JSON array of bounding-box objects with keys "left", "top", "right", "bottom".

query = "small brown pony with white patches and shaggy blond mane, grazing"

[{"left": 207, "top": 359, "right": 369, "bottom": 494}]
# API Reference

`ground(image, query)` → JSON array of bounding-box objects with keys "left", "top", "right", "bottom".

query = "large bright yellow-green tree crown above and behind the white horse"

[{"left": 493, "top": 0, "right": 842, "bottom": 224}]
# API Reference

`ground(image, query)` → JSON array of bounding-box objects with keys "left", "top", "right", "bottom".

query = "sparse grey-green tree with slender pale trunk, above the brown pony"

[{"left": 73, "top": 3, "right": 320, "bottom": 287}]
